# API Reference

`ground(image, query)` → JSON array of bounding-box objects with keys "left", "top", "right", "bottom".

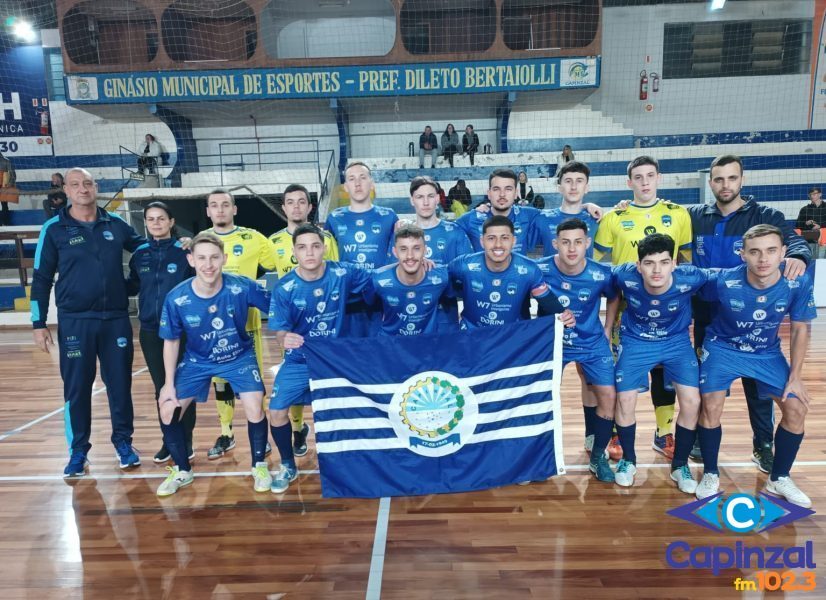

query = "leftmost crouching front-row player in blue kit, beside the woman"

[{"left": 157, "top": 233, "right": 272, "bottom": 496}]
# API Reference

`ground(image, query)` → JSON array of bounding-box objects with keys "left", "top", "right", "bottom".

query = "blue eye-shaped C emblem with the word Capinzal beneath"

[{"left": 665, "top": 492, "right": 816, "bottom": 575}]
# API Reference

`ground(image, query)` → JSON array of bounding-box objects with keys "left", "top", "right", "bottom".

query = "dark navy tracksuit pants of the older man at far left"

[{"left": 57, "top": 315, "right": 134, "bottom": 454}]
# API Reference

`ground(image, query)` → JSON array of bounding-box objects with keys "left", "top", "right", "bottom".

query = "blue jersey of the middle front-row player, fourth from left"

[{"left": 450, "top": 252, "right": 551, "bottom": 329}]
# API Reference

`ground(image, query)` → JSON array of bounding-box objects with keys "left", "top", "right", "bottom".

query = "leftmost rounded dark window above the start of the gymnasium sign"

[{"left": 62, "top": 0, "right": 158, "bottom": 65}]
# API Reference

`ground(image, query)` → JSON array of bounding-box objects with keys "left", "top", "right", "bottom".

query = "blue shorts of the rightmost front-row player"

[{"left": 700, "top": 340, "right": 789, "bottom": 398}]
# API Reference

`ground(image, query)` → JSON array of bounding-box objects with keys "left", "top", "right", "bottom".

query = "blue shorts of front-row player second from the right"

[{"left": 614, "top": 336, "right": 700, "bottom": 392}]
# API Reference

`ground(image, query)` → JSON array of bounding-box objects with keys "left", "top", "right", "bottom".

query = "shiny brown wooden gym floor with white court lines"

[{"left": 0, "top": 316, "right": 826, "bottom": 600}]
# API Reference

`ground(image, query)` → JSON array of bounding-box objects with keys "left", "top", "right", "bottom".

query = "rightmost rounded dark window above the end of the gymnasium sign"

[{"left": 502, "top": 0, "right": 599, "bottom": 50}]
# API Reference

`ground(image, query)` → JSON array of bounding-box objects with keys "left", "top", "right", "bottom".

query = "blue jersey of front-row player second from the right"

[{"left": 612, "top": 263, "right": 709, "bottom": 341}]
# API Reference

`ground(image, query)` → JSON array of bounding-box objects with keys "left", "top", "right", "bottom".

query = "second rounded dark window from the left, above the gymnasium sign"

[{"left": 161, "top": 0, "right": 258, "bottom": 62}]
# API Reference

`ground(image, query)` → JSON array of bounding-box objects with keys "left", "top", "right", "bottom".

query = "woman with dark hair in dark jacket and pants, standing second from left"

[{"left": 127, "top": 202, "right": 195, "bottom": 463}]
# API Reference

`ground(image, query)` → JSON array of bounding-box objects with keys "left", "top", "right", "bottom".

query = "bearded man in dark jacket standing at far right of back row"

[{"left": 688, "top": 155, "right": 811, "bottom": 473}]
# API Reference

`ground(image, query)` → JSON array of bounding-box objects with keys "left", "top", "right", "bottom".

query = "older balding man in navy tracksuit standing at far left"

[{"left": 31, "top": 168, "right": 146, "bottom": 477}]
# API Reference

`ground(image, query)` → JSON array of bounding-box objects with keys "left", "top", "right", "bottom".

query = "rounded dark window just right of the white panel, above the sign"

[{"left": 399, "top": 0, "right": 496, "bottom": 54}]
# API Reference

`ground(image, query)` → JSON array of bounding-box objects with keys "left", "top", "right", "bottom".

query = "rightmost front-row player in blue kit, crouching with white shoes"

[{"left": 697, "top": 225, "right": 817, "bottom": 508}]
